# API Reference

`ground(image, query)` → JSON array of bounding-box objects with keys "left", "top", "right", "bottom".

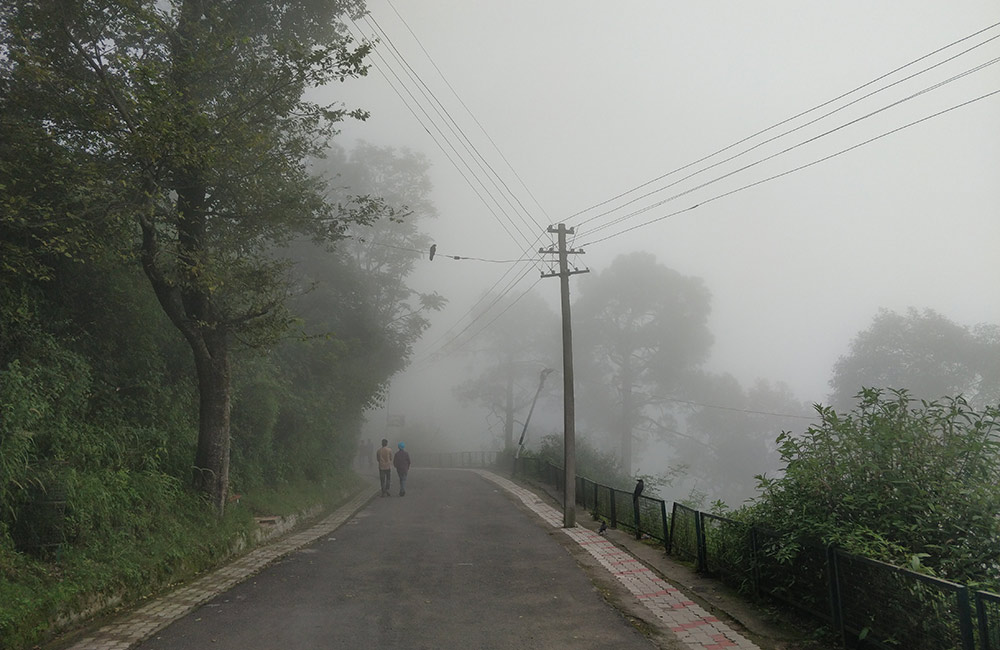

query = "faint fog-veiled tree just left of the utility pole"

[{"left": 454, "top": 293, "right": 561, "bottom": 449}]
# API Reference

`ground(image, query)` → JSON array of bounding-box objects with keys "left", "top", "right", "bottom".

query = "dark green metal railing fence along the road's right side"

[{"left": 515, "top": 458, "right": 1000, "bottom": 650}]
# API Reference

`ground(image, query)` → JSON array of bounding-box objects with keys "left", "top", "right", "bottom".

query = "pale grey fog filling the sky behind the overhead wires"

[{"left": 320, "top": 0, "right": 1000, "bottom": 502}]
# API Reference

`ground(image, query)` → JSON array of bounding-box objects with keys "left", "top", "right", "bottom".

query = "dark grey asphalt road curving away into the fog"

[{"left": 138, "top": 469, "right": 655, "bottom": 650}]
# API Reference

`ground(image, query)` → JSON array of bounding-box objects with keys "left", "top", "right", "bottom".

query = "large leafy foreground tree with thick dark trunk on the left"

[{"left": 0, "top": 0, "right": 371, "bottom": 511}]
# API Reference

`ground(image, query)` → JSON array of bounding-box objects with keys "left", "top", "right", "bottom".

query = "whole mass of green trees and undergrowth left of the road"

[{"left": 0, "top": 0, "right": 444, "bottom": 650}]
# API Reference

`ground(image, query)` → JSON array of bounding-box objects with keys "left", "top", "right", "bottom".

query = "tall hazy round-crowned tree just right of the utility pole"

[{"left": 573, "top": 252, "right": 712, "bottom": 475}]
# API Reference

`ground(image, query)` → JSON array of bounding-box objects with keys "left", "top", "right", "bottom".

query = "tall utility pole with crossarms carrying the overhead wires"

[{"left": 538, "top": 223, "right": 589, "bottom": 528}]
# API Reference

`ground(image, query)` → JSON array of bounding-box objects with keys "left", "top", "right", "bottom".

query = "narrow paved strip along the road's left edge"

[{"left": 68, "top": 488, "right": 376, "bottom": 650}]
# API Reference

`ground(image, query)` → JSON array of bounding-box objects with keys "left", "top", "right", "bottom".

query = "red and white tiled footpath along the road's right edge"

[{"left": 474, "top": 470, "right": 760, "bottom": 650}]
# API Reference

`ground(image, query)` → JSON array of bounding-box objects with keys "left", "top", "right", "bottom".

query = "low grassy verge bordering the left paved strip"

[{"left": 0, "top": 473, "right": 361, "bottom": 650}]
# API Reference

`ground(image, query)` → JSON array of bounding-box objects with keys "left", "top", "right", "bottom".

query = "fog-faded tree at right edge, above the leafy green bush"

[{"left": 830, "top": 309, "right": 1000, "bottom": 408}]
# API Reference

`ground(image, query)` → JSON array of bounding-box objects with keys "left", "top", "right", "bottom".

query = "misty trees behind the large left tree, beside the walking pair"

[{"left": 227, "top": 145, "right": 444, "bottom": 486}]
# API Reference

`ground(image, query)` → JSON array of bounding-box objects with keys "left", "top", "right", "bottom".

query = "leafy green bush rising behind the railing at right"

[{"left": 745, "top": 389, "right": 1000, "bottom": 589}]
